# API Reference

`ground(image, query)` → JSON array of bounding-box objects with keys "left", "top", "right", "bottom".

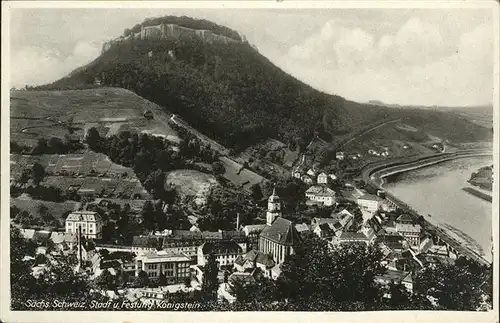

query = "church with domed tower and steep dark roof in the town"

[{"left": 259, "top": 189, "right": 300, "bottom": 265}]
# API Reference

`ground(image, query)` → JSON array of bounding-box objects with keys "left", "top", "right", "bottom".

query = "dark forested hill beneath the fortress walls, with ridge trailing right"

[{"left": 38, "top": 16, "right": 492, "bottom": 156}]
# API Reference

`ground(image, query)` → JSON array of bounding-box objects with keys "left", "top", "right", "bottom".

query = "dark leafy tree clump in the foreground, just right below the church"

[{"left": 278, "top": 234, "right": 385, "bottom": 310}]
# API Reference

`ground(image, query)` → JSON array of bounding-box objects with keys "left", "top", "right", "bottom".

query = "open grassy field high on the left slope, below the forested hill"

[{"left": 10, "top": 88, "right": 177, "bottom": 146}]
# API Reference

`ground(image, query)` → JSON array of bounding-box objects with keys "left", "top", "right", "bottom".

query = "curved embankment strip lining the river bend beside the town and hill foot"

[{"left": 361, "top": 149, "right": 492, "bottom": 265}]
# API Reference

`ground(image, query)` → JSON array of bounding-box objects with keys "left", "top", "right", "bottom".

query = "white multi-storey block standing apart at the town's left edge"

[{"left": 65, "top": 211, "right": 102, "bottom": 239}]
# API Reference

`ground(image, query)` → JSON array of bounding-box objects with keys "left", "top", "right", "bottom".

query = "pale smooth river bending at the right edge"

[{"left": 384, "top": 157, "right": 493, "bottom": 261}]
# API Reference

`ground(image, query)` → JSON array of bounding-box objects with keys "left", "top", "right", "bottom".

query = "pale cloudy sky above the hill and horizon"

[{"left": 10, "top": 8, "right": 498, "bottom": 106}]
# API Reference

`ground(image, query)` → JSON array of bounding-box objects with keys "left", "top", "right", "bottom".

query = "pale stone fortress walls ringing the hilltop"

[{"left": 102, "top": 24, "right": 240, "bottom": 53}]
